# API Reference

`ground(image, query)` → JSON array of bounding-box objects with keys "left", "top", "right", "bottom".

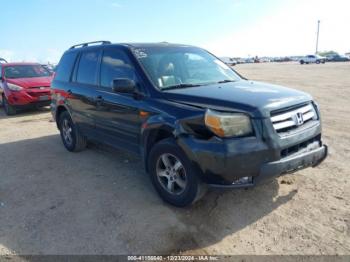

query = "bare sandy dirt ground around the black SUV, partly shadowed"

[{"left": 0, "top": 63, "right": 350, "bottom": 254}]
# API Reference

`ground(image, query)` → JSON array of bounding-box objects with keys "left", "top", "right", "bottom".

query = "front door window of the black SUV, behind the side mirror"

[{"left": 101, "top": 49, "right": 136, "bottom": 87}]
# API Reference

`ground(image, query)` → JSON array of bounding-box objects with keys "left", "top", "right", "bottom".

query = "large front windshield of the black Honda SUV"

[{"left": 133, "top": 46, "right": 240, "bottom": 90}]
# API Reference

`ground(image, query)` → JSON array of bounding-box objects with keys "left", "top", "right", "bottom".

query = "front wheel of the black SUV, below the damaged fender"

[{"left": 148, "top": 139, "right": 207, "bottom": 207}]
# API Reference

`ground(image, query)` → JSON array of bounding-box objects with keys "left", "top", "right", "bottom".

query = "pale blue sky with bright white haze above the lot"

[{"left": 0, "top": 0, "right": 350, "bottom": 63}]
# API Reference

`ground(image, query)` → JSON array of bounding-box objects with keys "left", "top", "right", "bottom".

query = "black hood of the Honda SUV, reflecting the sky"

[{"left": 162, "top": 80, "right": 312, "bottom": 117}]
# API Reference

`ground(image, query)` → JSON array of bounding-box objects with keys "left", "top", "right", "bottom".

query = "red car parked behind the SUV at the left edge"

[{"left": 0, "top": 63, "right": 52, "bottom": 115}]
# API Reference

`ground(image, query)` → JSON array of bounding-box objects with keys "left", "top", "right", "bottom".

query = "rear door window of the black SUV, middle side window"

[{"left": 77, "top": 50, "right": 100, "bottom": 85}]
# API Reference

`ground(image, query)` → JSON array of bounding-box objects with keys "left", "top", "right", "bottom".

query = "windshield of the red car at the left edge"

[{"left": 4, "top": 65, "right": 50, "bottom": 78}]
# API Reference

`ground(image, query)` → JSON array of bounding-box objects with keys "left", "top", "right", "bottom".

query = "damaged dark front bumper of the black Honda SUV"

[{"left": 178, "top": 121, "right": 328, "bottom": 188}]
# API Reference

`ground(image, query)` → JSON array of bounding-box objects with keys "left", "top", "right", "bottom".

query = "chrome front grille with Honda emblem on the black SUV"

[{"left": 271, "top": 103, "right": 318, "bottom": 134}]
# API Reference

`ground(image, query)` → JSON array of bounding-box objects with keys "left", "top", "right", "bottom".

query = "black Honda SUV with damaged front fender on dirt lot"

[{"left": 51, "top": 41, "right": 327, "bottom": 206}]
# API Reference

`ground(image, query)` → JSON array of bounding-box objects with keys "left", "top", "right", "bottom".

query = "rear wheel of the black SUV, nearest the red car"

[{"left": 59, "top": 111, "right": 87, "bottom": 152}]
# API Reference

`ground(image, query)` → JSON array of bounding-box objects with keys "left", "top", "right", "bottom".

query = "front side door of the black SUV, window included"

[{"left": 95, "top": 47, "right": 141, "bottom": 152}]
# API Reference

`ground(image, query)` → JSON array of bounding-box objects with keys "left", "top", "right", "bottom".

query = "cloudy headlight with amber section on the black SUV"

[{"left": 205, "top": 109, "right": 253, "bottom": 137}]
